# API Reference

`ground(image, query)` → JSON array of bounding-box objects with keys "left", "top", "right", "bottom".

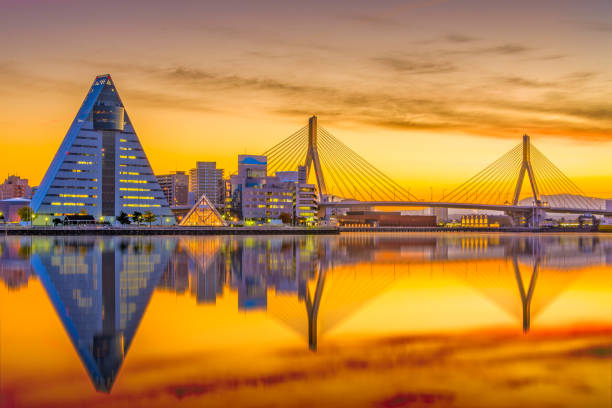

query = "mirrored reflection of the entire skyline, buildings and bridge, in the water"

[{"left": 0, "top": 234, "right": 612, "bottom": 404}]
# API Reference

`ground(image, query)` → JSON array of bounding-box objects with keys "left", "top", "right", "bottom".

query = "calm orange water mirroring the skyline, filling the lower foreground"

[{"left": 0, "top": 234, "right": 612, "bottom": 408}]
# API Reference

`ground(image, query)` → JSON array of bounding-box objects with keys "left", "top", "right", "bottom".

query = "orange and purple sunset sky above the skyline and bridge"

[{"left": 0, "top": 0, "right": 612, "bottom": 197}]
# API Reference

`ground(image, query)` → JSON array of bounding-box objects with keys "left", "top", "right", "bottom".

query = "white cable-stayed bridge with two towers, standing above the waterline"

[{"left": 264, "top": 116, "right": 607, "bottom": 226}]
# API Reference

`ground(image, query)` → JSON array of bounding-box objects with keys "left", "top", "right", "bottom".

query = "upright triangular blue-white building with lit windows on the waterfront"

[{"left": 32, "top": 75, "right": 176, "bottom": 224}]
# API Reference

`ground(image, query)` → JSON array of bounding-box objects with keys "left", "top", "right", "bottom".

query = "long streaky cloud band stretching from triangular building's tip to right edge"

[{"left": 65, "top": 58, "right": 612, "bottom": 141}]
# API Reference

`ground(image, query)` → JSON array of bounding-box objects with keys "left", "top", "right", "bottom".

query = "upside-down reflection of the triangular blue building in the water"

[{"left": 32, "top": 238, "right": 174, "bottom": 392}]
